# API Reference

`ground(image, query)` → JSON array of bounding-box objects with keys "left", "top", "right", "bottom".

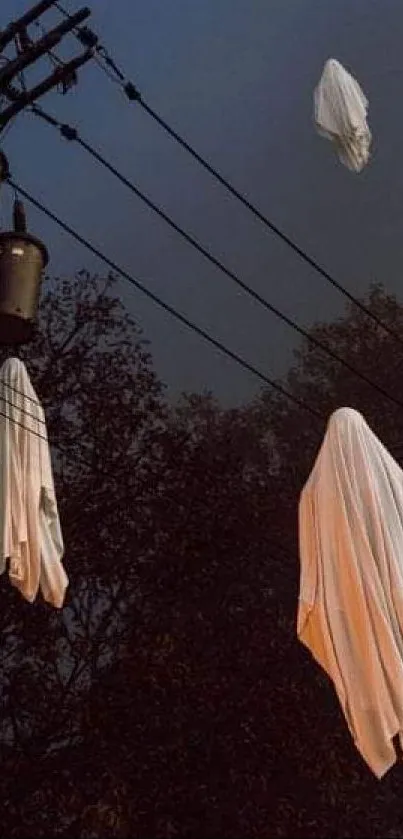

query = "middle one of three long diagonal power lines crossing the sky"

[{"left": 31, "top": 105, "right": 403, "bottom": 408}]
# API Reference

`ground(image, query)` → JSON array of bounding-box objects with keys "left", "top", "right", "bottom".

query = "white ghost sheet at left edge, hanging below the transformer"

[{"left": 0, "top": 358, "right": 68, "bottom": 608}]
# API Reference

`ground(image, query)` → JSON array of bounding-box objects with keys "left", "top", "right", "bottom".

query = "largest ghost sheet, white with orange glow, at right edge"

[{"left": 297, "top": 408, "right": 403, "bottom": 778}]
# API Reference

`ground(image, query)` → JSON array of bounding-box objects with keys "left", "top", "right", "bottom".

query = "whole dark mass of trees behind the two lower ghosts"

[{"left": 0, "top": 282, "right": 403, "bottom": 839}]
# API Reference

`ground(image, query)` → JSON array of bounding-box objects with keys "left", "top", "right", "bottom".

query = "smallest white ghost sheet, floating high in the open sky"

[{"left": 314, "top": 58, "right": 372, "bottom": 172}]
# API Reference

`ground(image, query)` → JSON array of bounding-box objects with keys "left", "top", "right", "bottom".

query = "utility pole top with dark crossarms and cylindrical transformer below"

[{"left": 0, "top": 0, "right": 96, "bottom": 346}]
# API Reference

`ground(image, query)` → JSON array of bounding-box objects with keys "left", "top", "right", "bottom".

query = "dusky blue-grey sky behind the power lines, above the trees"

[{"left": 0, "top": 0, "right": 403, "bottom": 404}]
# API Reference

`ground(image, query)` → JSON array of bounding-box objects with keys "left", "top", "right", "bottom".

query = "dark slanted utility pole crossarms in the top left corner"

[{"left": 0, "top": 0, "right": 94, "bottom": 130}]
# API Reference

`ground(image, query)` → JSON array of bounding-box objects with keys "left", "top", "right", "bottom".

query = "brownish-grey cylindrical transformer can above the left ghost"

[{"left": 0, "top": 231, "right": 49, "bottom": 345}]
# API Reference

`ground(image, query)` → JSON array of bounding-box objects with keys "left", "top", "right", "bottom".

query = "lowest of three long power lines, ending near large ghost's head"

[{"left": 8, "top": 177, "right": 326, "bottom": 422}]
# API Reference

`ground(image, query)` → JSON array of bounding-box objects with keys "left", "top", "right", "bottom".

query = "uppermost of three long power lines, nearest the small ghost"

[{"left": 55, "top": 2, "right": 403, "bottom": 354}]
